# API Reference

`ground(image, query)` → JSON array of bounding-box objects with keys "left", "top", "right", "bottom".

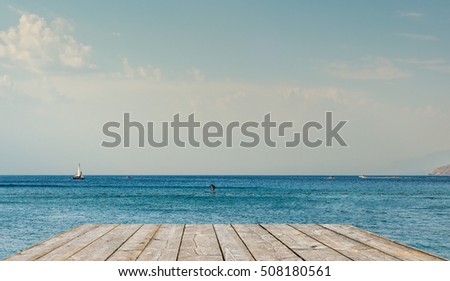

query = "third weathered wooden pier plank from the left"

[{"left": 67, "top": 224, "right": 141, "bottom": 261}]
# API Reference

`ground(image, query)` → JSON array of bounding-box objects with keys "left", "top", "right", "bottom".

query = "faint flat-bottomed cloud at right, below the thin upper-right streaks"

[{"left": 327, "top": 57, "right": 410, "bottom": 80}]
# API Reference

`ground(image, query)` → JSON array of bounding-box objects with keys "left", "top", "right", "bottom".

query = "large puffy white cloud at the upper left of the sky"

[{"left": 0, "top": 11, "right": 92, "bottom": 72}]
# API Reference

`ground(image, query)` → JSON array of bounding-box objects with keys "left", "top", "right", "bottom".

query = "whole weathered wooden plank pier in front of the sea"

[{"left": 6, "top": 224, "right": 445, "bottom": 261}]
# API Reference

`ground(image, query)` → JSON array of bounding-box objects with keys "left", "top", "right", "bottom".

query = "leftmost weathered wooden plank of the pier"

[{"left": 5, "top": 224, "right": 98, "bottom": 261}]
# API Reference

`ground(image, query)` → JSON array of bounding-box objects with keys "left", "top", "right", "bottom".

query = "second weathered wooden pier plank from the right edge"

[{"left": 292, "top": 224, "right": 398, "bottom": 261}]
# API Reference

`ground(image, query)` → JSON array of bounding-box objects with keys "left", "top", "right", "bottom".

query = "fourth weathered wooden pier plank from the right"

[{"left": 233, "top": 224, "right": 301, "bottom": 261}]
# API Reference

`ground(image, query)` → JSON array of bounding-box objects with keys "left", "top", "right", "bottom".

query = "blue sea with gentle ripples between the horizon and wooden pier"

[{"left": 0, "top": 176, "right": 450, "bottom": 259}]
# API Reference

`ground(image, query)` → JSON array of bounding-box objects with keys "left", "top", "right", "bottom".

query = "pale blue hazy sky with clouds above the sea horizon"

[{"left": 0, "top": 0, "right": 450, "bottom": 175}]
